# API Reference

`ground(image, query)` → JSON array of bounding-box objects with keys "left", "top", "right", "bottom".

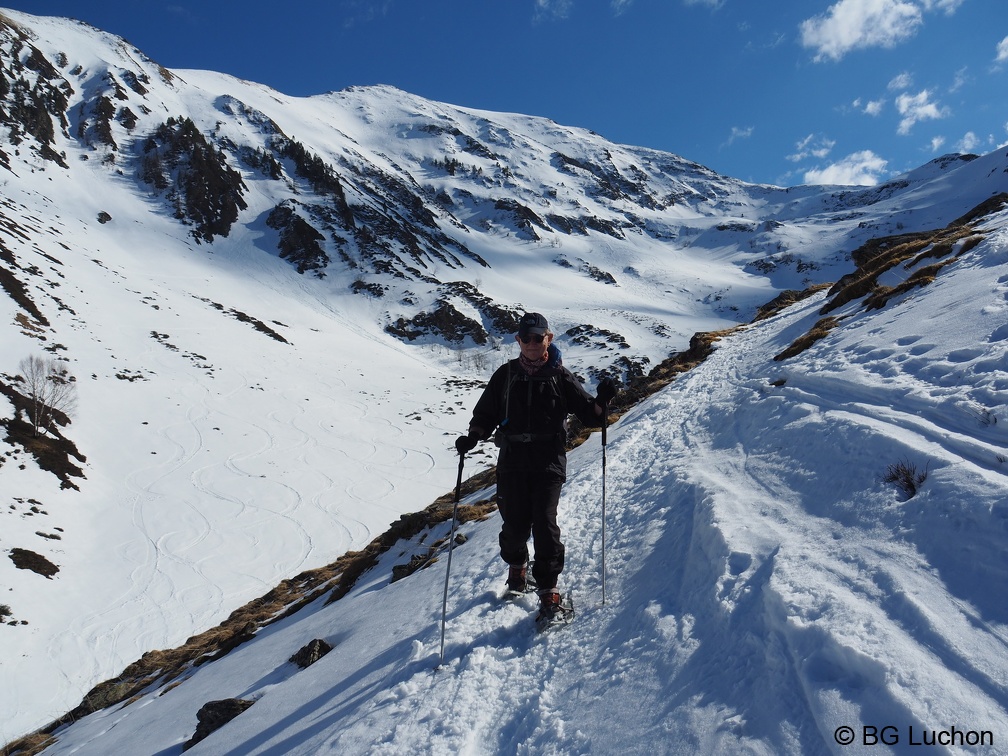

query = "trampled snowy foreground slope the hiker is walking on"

[{"left": 27, "top": 202, "right": 1008, "bottom": 755}]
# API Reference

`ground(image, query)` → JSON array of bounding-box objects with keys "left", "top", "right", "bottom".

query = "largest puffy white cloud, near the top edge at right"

[{"left": 799, "top": 0, "right": 922, "bottom": 60}]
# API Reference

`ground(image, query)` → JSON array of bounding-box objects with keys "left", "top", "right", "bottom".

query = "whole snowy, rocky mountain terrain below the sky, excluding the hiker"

[{"left": 0, "top": 10, "right": 1008, "bottom": 754}]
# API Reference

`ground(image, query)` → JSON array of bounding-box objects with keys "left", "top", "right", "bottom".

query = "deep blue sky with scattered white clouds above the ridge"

[{"left": 7, "top": 0, "right": 1008, "bottom": 185}]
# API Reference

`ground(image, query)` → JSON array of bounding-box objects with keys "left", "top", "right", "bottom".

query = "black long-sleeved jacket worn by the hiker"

[{"left": 470, "top": 348, "right": 602, "bottom": 477}]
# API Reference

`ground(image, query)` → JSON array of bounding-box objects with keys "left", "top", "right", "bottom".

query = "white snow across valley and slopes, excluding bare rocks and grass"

[{"left": 0, "top": 7, "right": 1008, "bottom": 756}]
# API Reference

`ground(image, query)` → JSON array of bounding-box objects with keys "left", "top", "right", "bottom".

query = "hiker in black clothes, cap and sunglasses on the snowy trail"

[{"left": 456, "top": 312, "right": 616, "bottom": 619}]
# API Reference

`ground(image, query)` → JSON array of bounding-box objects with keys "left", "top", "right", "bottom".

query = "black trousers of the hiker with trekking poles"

[{"left": 497, "top": 468, "right": 564, "bottom": 591}]
